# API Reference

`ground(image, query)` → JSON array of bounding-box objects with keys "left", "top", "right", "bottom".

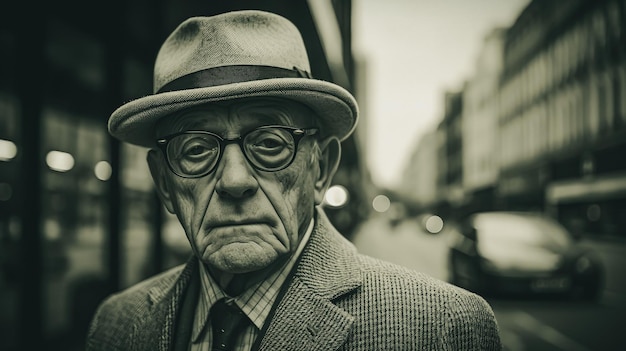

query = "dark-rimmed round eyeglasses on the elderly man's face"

[{"left": 156, "top": 126, "right": 318, "bottom": 178}]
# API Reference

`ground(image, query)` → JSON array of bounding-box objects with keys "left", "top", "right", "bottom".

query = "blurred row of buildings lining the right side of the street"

[{"left": 400, "top": 0, "right": 626, "bottom": 238}]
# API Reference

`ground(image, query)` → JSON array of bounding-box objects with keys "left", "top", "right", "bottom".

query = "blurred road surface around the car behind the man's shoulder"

[{"left": 353, "top": 215, "right": 626, "bottom": 351}]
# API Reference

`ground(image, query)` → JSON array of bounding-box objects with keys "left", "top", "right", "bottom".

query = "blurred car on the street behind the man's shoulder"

[{"left": 448, "top": 212, "right": 604, "bottom": 300}]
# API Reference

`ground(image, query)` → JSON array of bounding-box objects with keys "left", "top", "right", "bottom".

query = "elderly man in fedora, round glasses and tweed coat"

[{"left": 87, "top": 11, "right": 500, "bottom": 351}]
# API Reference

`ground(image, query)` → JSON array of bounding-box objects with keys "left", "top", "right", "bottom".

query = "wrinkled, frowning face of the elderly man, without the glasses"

[{"left": 149, "top": 100, "right": 327, "bottom": 274}]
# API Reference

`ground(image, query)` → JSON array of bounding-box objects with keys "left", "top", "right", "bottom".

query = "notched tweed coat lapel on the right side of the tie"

[{"left": 259, "top": 211, "right": 361, "bottom": 351}]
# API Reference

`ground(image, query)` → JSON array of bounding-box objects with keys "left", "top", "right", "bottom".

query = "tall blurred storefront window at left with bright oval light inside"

[{"left": 42, "top": 108, "right": 108, "bottom": 346}]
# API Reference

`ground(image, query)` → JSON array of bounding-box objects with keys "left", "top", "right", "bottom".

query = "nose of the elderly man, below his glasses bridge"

[{"left": 215, "top": 144, "right": 259, "bottom": 199}]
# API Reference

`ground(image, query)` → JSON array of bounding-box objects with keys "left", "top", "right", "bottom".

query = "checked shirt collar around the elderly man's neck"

[{"left": 191, "top": 219, "right": 314, "bottom": 342}]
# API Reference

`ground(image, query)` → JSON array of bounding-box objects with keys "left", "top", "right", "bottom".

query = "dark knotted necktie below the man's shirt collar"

[{"left": 211, "top": 299, "right": 248, "bottom": 351}]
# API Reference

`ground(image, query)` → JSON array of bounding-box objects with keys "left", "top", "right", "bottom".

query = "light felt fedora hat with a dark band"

[{"left": 108, "top": 10, "right": 358, "bottom": 147}]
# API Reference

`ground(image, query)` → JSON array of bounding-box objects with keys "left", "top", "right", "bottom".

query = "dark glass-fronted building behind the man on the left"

[{"left": 0, "top": 0, "right": 364, "bottom": 351}]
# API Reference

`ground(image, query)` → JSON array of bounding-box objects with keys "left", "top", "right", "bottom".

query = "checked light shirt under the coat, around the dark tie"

[{"left": 190, "top": 220, "right": 313, "bottom": 351}]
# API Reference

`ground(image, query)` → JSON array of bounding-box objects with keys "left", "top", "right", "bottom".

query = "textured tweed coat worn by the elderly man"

[{"left": 87, "top": 211, "right": 502, "bottom": 351}]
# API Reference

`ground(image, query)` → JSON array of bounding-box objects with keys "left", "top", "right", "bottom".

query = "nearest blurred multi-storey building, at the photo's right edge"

[{"left": 498, "top": 0, "right": 626, "bottom": 236}]
